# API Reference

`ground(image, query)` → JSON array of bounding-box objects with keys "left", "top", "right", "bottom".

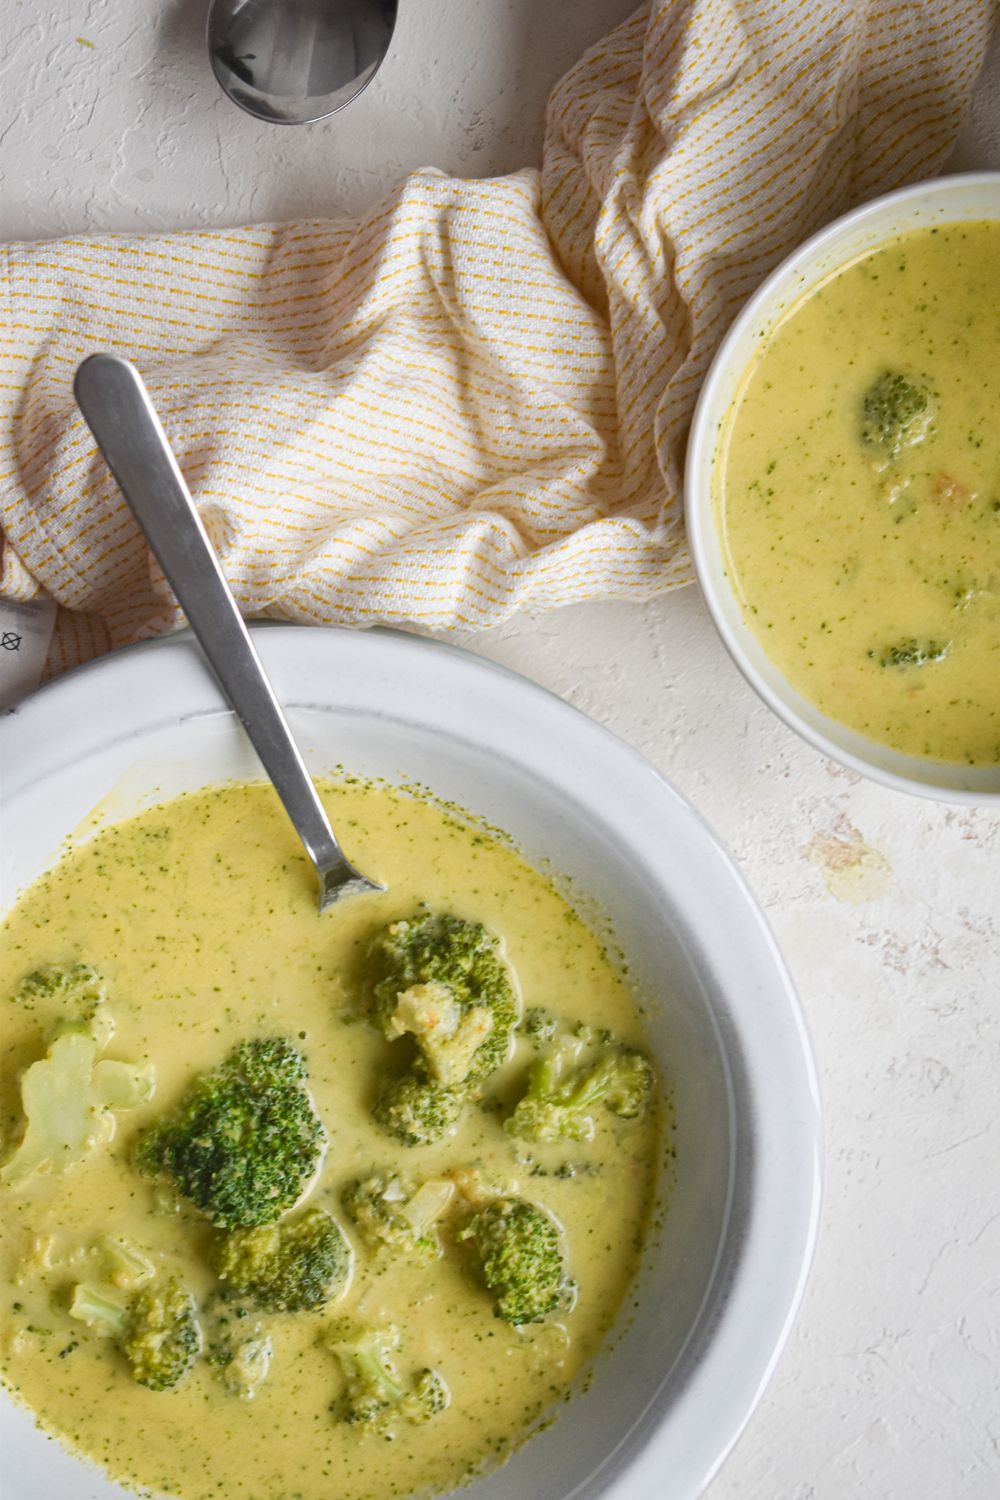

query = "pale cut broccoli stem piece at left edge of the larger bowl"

[{"left": 0, "top": 1005, "right": 154, "bottom": 1188}]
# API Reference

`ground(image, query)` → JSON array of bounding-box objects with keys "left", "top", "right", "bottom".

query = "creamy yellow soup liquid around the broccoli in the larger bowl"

[{"left": 0, "top": 783, "right": 660, "bottom": 1500}]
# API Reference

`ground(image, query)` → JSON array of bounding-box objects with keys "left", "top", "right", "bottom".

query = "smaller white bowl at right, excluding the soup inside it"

[{"left": 685, "top": 173, "right": 1000, "bottom": 803}]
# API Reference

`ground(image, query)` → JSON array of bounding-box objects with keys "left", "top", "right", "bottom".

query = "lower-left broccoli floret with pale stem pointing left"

[{"left": 69, "top": 1277, "right": 201, "bottom": 1391}]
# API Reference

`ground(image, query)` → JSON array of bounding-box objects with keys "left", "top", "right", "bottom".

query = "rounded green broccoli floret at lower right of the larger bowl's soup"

[{"left": 459, "top": 1199, "right": 570, "bottom": 1325}]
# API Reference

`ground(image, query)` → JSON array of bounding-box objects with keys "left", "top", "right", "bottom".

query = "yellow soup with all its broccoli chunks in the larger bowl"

[{"left": 0, "top": 780, "right": 661, "bottom": 1500}]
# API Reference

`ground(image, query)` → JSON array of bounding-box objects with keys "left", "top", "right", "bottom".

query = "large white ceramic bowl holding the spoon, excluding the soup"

[{"left": 0, "top": 627, "right": 820, "bottom": 1500}]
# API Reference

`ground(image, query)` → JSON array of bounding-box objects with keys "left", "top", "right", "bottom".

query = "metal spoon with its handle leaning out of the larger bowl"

[{"left": 73, "top": 354, "right": 385, "bottom": 912}]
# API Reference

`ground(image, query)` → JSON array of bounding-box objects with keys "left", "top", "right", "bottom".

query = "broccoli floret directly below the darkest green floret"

[{"left": 211, "top": 1208, "right": 351, "bottom": 1313}]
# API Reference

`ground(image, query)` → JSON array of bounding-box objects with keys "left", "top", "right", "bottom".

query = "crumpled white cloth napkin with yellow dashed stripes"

[{"left": 0, "top": 0, "right": 994, "bottom": 671}]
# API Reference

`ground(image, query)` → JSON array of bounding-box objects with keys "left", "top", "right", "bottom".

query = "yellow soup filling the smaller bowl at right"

[{"left": 715, "top": 222, "right": 1000, "bottom": 765}]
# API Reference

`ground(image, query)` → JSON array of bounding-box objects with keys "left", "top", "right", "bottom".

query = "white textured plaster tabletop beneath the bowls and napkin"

[{"left": 0, "top": 0, "right": 1000, "bottom": 1500}]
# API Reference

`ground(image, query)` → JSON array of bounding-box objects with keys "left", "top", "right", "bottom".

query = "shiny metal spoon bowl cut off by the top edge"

[{"left": 208, "top": 0, "right": 396, "bottom": 125}]
